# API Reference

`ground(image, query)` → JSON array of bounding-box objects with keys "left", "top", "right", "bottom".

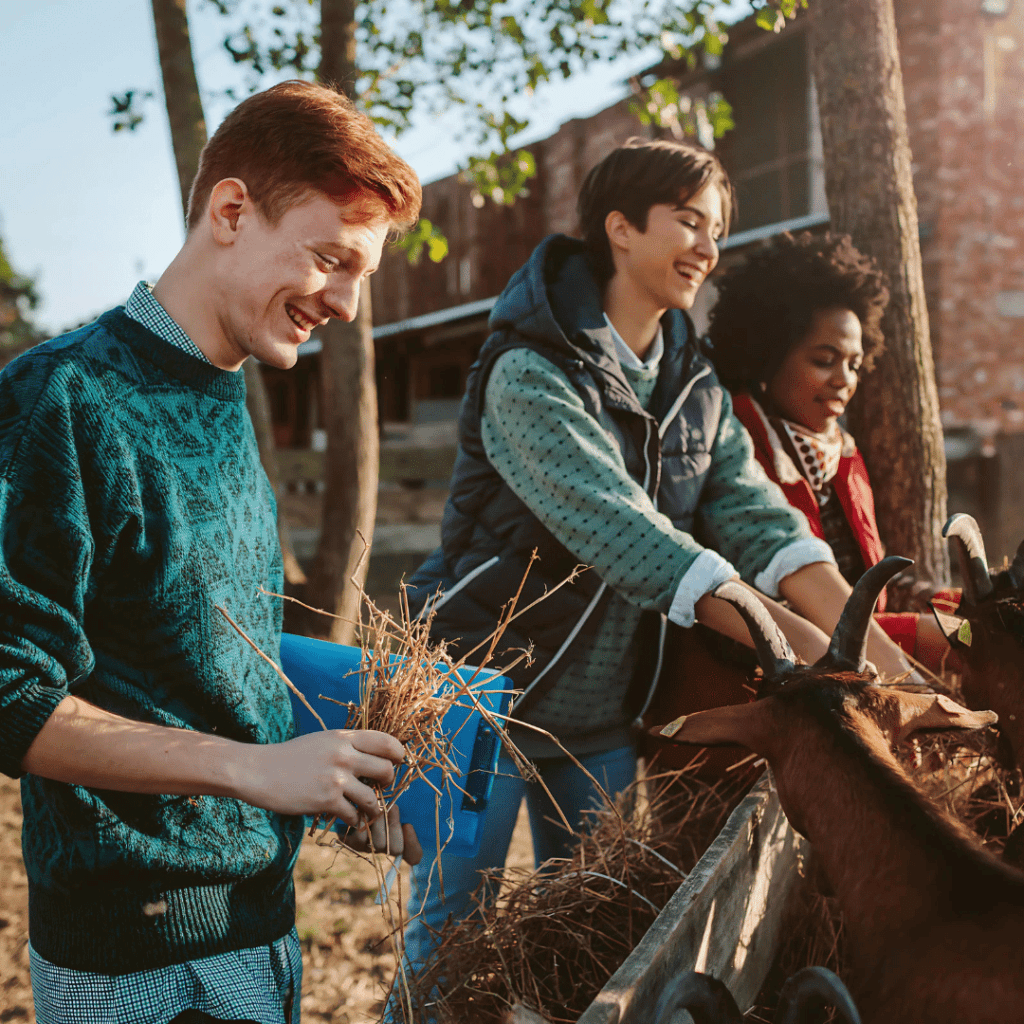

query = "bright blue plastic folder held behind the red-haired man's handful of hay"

[{"left": 281, "top": 633, "right": 513, "bottom": 857}]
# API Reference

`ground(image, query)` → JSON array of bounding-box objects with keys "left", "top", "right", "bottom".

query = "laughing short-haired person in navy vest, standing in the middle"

[{"left": 395, "top": 140, "right": 906, "bottom": 962}]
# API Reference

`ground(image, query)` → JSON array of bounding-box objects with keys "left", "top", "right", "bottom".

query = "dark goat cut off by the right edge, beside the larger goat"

[{"left": 936, "top": 514, "right": 1024, "bottom": 768}]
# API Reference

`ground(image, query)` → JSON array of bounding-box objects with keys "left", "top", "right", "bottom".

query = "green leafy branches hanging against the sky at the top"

[{"left": 110, "top": 0, "right": 808, "bottom": 242}]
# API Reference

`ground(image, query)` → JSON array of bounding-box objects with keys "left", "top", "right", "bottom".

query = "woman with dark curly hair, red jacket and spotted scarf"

[{"left": 709, "top": 231, "right": 948, "bottom": 667}]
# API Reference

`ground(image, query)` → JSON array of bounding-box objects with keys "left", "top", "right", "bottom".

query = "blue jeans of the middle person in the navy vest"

[{"left": 395, "top": 746, "right": 637, "bottom": 972}]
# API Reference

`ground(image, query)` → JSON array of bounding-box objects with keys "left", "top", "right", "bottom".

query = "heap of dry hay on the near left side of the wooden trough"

[{"left": 406, "top": 770, "right": 753, "bottom": 1024}]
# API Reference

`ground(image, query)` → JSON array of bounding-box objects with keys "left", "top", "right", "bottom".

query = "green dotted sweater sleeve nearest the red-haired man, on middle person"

[{"left": 481, "top": 349, "right": 703, "bottom": 613}]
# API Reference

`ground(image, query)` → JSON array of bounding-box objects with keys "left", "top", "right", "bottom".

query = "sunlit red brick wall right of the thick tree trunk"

[{"left": 897, "top": 0, "right": 1024, "bottom": 435}]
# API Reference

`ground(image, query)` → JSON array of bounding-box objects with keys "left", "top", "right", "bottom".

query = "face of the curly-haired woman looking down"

[{"left": 768, "top": 307, "right": 864, "bottom": 434}]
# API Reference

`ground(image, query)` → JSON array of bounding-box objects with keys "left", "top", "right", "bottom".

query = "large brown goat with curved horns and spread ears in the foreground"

[{"left": 660, "top": 558, "right": 1024, "bottom": 1024}]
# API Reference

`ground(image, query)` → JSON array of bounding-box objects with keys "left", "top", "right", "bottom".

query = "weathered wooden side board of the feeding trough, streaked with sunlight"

[{"left": 579, "top": 773, "right": 809, "bottom": 1024}]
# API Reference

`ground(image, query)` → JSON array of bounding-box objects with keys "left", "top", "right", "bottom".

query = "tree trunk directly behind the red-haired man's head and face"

[{"left": 306, "top": 0, "right": 379, "bottom": 643}]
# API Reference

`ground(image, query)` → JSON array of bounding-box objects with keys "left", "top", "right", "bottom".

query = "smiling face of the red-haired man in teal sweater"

[{"left": 221, "top": 193, "right": 389, "bottom": 369}]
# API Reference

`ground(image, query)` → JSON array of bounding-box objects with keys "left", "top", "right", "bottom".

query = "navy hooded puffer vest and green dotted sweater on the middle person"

[{"left": 411, "top": 236, "right": 830, "bottom": 756}]
